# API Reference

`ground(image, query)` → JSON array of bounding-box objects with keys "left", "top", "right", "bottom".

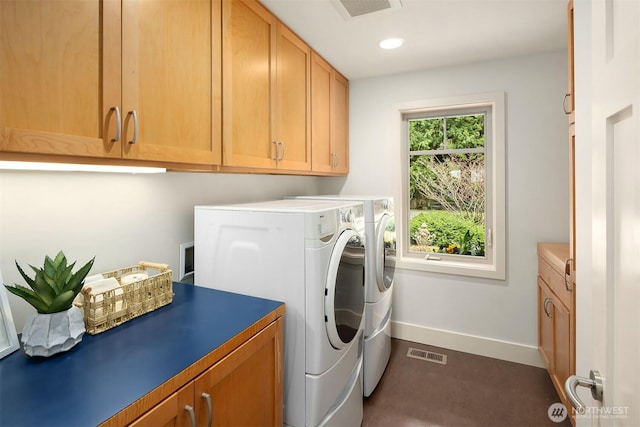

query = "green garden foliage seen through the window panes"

[{"left": 409, "top": 114, "right": 486, "bottom": 256}]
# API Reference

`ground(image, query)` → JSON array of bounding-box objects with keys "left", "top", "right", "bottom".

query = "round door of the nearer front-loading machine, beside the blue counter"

[{"left": 324, "top": 229, "right": 365, "bottom": 349}]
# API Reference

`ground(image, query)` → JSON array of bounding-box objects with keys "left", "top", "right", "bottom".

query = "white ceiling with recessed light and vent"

[{"left": 261, "top": 0, "right": 567, "bottom": 80}]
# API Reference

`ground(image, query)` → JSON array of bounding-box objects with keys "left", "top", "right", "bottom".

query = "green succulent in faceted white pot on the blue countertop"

[{"left": 4, "top": 251, "right": 95, "bottom": 356}]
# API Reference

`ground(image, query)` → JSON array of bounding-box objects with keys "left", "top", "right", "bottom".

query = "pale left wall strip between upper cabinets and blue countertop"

[{"left": 0, "top": 171, "right": 321, "bottom": 332}]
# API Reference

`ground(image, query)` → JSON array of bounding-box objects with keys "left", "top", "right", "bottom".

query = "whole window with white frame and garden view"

[{"left": 396, "top": 93, "right": 505, "bottom": 279}]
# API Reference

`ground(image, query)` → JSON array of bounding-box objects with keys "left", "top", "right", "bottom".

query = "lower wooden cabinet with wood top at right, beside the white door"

[{"left": 538, "top": 243, "right": 576, "bottom": 424}]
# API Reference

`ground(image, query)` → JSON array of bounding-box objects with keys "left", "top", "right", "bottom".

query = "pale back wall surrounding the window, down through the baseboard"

[{"left": 323, "top": 52, "right": 569, "bottom": 366}]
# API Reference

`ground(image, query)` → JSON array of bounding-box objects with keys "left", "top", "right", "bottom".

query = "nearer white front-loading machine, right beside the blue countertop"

[{"left": 194, "top": 200, "right": 365, "bottom": 426}]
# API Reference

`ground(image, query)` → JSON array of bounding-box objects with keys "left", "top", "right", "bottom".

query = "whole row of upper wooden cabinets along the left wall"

[{"left": 0, "top": 0, "right": 349, "bottom": 175}]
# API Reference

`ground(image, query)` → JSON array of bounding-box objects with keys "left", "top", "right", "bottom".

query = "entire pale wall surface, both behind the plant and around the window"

[{"left": 0, "top": 52, "right": 568, "bottom": 365}]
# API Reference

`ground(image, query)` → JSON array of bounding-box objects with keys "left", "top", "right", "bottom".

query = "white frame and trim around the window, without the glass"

[{"left": 394, "top": 92, "right": 506, "bottom": 280}]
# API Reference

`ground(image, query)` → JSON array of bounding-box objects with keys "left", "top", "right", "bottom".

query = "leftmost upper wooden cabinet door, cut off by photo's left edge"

[{"left": 0, "top": 0, "right": 121, "bottom": 157}]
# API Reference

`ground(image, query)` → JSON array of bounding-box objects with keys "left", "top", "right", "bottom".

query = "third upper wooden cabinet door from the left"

[{"left": 222, "top": 0, "right": 276, "bottom": 168}]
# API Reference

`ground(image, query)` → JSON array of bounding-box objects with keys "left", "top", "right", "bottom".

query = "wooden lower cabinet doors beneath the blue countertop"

[{"left": 130, "top": 317, "right": 283, "bottom": 427}]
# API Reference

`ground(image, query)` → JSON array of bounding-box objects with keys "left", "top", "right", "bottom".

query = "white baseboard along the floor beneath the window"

[{"left": 391, "top": 321, "right": 546, "bottom": 368}]
